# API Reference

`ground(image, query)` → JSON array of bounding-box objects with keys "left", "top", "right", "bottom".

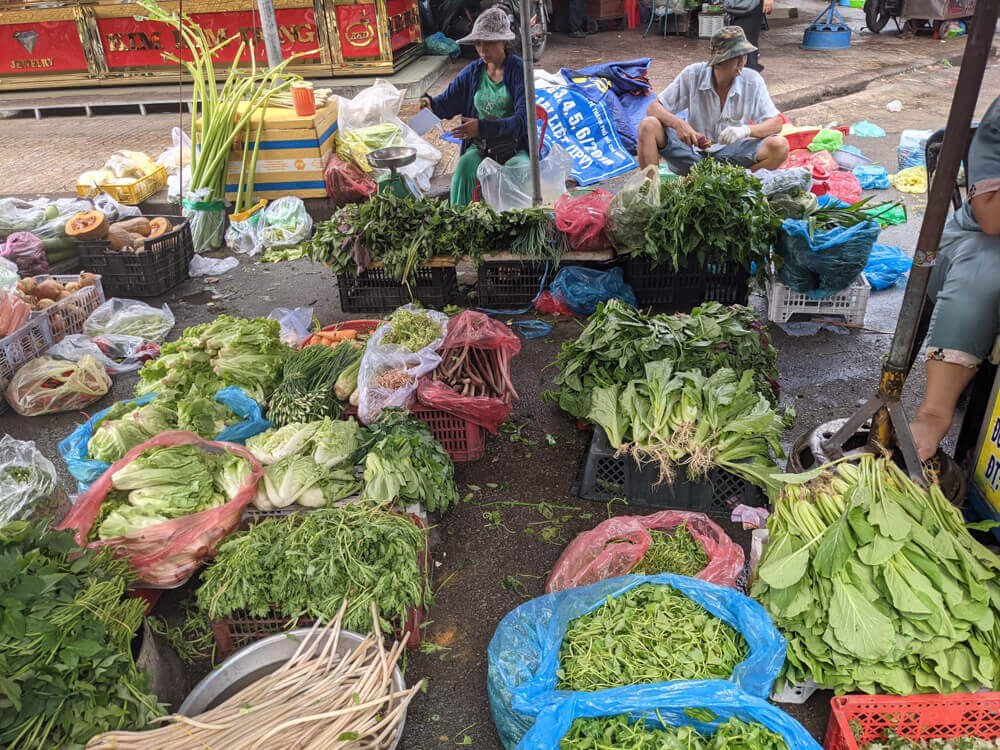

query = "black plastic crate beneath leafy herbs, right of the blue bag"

[{"left": 625, "top": 257, "right": 750, "bottom": 309}]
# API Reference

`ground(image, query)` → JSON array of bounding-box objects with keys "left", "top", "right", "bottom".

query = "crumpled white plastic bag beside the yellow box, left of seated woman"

[{"left": 337, "top": 78, "right": 441, "bottom": 193}]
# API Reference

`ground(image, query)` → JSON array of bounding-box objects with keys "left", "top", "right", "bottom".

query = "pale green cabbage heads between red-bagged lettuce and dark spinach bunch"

[{"left": 246, "top": 420, "right": 363, "bottom": 510}]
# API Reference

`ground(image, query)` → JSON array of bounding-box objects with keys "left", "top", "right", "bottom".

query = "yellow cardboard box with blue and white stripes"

[{"left": 226, "top": 100, "right": 337, "bottom": 200}]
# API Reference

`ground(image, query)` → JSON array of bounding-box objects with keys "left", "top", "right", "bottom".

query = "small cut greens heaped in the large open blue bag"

[{"left": 556, "top": 584, "right": 747, "bottom": 691}]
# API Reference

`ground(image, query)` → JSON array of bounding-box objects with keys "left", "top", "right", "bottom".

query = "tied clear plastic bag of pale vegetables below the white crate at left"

[{"left": 7, "top": 355, "right": 111, "bottom": 417}]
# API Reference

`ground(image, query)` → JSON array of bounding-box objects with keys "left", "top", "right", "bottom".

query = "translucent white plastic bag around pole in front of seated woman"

[{"left": 476, "top": 144, "right": 573, "bottom": 211}]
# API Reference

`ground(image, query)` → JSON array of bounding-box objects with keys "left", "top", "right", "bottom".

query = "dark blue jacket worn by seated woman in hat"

[{"left": 431, "top": 54, "right": 528, "bottom": 154}]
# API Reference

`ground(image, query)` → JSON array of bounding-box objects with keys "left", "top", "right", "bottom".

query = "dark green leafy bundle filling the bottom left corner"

[{"left": 0, "top": 522, "right": 163, "bottom": 750}]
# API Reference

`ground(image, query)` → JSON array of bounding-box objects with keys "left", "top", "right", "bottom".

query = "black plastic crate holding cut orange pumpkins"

[{"left": 77, "top": 216, "right": 194, "bottom": 297}]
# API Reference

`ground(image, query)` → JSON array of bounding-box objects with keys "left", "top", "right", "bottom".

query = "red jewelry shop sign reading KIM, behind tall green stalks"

[{"left": 97, "top": 8, "right": 323, "bottom": 69}]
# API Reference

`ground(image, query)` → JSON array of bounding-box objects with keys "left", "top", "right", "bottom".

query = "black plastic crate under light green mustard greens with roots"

[{"left": 574, "top": 426, "right": 765, "bottom": 516}]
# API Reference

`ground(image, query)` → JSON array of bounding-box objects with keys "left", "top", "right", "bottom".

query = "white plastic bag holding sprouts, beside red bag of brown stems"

[{"left": 358, "top": 305, "right": 448, "bottom": 425}]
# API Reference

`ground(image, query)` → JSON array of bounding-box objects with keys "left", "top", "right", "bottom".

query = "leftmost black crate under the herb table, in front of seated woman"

[{"left": 337, "top": 266, "right": 458, "bottom": 313}]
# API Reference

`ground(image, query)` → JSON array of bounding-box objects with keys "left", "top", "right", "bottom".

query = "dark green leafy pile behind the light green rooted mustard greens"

[{"left": 544, "top": 300, "right": 778, "bottom": 419}]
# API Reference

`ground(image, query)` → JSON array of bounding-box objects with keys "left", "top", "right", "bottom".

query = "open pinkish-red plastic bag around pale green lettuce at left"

[{"left": 55, "top": 430, "right": 263, "bottom": 587}]
